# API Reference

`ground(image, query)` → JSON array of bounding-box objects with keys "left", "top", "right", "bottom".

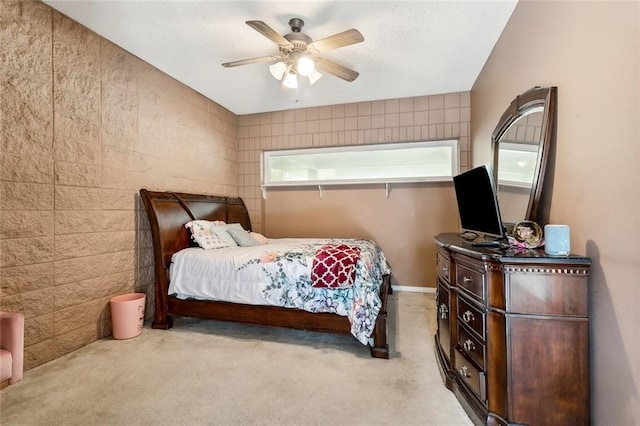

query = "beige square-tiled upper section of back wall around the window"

[{"left": 238, "top": 93, "right": 471, "bottom": 231}]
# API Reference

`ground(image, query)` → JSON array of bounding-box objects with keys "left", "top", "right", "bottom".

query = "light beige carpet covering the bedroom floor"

[{"left": 0, "top": 292, "right": 471, "bottom": 426}]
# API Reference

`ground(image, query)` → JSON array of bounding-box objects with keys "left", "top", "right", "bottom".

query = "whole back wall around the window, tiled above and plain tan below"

[{"left": 238, "top": 92, "right": 470, "bottom": 287}]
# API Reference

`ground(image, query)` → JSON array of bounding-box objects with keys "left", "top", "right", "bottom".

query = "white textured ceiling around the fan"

[{"left": 45, "top": 0, "right": 517, "bottom": 114}]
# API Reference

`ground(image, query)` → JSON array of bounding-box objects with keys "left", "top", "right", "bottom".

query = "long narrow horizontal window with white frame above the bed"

[{"left": 262, "top": 139, "right": 459, "bottom": 187}]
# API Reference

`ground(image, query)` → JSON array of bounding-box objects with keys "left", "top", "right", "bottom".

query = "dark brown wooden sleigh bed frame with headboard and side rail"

[{"left": 140, "top": 189, "right": 391, "bottom": 359}]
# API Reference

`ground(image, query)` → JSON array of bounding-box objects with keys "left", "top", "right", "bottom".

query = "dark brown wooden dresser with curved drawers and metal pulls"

[{"left": 435, "top": 234, "right": 591, "bottom": 425}]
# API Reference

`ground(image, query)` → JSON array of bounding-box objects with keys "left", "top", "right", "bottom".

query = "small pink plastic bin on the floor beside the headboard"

[{"left": 110, "top": 293, "right": 147, "bottom": 339}]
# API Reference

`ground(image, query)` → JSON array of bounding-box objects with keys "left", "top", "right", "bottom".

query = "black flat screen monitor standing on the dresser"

[{"left": 453, "top": 166, "right": 506, "bottom": 239}]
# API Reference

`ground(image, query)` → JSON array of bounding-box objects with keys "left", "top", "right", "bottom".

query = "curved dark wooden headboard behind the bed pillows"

[{"left": 140, "top": 189, "right": 251, "bottom": 270}]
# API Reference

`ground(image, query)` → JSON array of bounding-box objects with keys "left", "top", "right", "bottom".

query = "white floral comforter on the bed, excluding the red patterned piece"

[{"left": 169, "top": 238, "right": 391, "bottom": 345}]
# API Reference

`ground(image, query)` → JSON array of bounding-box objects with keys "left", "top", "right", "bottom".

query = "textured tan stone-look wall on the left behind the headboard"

[{"left": 0, "top": 1, "right": 238, "bottom": 368}]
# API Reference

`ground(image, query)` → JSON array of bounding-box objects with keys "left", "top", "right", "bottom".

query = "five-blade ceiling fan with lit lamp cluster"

[{"left": 222, "top": 18, "right": 364, "bottom": 88}]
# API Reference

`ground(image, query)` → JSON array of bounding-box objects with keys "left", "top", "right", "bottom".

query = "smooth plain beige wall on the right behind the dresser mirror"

[{"left": 471, "top": 1, "right": 640, "bottom": 425}]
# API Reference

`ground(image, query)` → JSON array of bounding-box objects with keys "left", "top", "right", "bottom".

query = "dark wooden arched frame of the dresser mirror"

[{"left": 491, "top": 86, "right": 558, "bottom": 225}]
